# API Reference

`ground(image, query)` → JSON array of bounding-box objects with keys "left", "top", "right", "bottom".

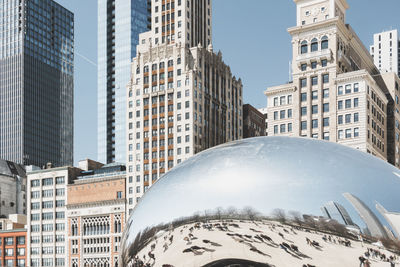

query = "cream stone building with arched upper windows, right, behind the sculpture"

[{"left": 265, "top": 0, "right": 398, "bottom": 168}]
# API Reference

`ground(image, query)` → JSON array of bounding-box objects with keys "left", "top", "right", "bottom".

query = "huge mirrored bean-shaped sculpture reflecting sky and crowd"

[{"left": 121, "top": 137, "right": 400, "bottom": 267}]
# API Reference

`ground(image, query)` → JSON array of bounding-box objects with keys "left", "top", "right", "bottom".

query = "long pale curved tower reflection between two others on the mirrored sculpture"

[{"left": 343, "top": 193, "right": 388, "bottom": 238}]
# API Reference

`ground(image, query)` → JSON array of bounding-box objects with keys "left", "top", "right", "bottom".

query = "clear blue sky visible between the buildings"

[{"left": 56, "top": 0, "right": 400, "bottom": 165}]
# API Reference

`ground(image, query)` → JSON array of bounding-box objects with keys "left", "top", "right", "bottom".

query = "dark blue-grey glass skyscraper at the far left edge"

[{"left": 0, "top": 0, "right": 74, "bottom": 166}]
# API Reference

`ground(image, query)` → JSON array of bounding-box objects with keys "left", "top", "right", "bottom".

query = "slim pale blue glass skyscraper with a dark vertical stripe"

[{"left": 97, "top": 0, "right": 151, "bottom": 163}]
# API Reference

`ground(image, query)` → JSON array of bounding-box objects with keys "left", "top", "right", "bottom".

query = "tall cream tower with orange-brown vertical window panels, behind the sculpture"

[{"left": 126, "top": 0, "right": 243, "bottom": 214}]
